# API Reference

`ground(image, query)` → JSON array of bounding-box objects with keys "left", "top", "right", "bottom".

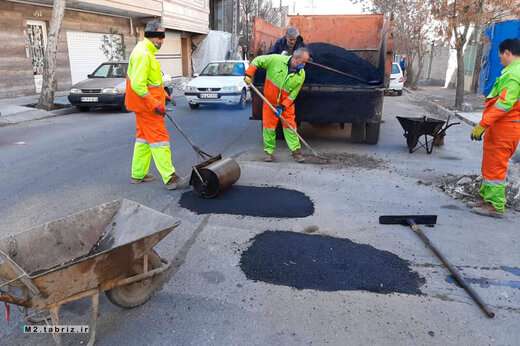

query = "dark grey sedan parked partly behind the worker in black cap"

[{"left": 69, "top": 61, "right": 172, "bottom": 112}]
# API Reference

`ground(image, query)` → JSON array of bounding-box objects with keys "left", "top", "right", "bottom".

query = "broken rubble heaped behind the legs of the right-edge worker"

[{"left": 439, "top": 164, "right": 520, "bottom": 211}]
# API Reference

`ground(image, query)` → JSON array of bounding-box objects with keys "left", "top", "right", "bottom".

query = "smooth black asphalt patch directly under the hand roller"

[{"left": 179, "top": 185, "right": 314, "bottom": 218}]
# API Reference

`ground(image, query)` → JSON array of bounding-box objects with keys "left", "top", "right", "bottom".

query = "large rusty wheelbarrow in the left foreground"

[{"left": 0, "top": 199, "right": 180, "bottom": 345}]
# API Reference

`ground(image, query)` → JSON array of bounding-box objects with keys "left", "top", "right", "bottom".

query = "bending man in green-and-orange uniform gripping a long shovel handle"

[{"left": 244, "top": 48, "right": 310, "bottom": 163}]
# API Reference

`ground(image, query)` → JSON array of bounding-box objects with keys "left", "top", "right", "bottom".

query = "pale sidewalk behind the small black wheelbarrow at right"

[{"left": 406, "top": 86, "right": 485, "bottom": 126}]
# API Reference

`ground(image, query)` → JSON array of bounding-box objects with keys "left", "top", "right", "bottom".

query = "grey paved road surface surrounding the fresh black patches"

[{"left": 0, "top": 96, "right": 520, "bottom": 345}]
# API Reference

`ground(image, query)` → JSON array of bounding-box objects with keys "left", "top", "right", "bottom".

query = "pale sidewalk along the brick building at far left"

[{"left": 0, "top": 91, "right": 73, "bottom": 126}]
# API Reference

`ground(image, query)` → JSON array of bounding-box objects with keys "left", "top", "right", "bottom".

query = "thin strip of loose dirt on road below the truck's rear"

[{"left": 303, "top": 153, "right": 387, "bottom": 169}]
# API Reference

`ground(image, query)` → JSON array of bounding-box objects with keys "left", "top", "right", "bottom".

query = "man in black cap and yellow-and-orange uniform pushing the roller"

[{"left": 125, "top": 20, "right": 180, "bottom": 190}]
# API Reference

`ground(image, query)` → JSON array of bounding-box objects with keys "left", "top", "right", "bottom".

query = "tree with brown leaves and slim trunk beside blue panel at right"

[{"left": 430, "top": 0, "right": 520, "bottom": 109}]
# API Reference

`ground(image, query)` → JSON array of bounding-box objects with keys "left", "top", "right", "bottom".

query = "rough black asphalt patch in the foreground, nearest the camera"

[{"left": 240, "top": 231, "right": 425, "bottom": 295}]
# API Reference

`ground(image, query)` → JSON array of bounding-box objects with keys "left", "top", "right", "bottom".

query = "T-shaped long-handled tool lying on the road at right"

[{"left": 379, "top": 215, "right": 495, "bottom": 318}]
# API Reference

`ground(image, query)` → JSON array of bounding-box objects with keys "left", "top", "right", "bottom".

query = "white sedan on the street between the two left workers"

[{"left": 184, "top": 60, "right": 250, "bottom": 109}]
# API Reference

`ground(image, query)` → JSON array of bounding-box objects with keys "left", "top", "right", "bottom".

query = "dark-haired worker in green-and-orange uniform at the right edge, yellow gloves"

[{"left": 471, "top": 39, "right": 520, "bottom": 217}]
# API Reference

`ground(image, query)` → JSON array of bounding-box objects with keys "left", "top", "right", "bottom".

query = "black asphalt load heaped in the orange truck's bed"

[{"left": 305, "top": 43, "right": 384, "bottom": 85}]
